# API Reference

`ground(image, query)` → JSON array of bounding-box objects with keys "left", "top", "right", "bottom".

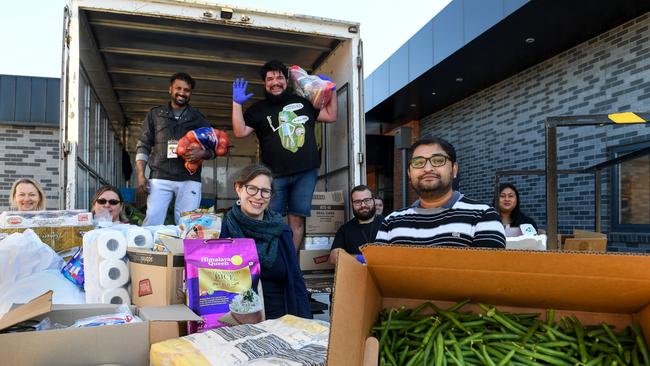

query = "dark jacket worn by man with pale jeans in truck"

[{"left": 136, "top": 104, "right": 215, "bottom": 182}]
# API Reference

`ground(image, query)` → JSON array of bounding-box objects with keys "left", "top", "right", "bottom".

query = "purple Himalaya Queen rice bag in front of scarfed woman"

[{"left": 183, "top": 238, "right": 261, "bottom": 333}]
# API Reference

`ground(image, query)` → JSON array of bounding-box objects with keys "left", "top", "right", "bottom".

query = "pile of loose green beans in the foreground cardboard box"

[{"left": 372, "top": 300, "right": 650, "bottom": 366}]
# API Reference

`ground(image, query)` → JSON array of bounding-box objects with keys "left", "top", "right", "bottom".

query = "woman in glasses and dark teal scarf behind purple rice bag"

[{"left": 221, "top": 165, "right": 312, "bottom": 319}]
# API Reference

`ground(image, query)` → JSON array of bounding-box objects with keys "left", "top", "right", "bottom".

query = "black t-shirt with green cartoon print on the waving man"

[{"left": 244, "top": 95, "right": 320, "bottom": 177}]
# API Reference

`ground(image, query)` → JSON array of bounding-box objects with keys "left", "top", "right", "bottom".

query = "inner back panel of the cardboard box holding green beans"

[{"left": 360, "top": 245, "right": 650, "bottom": 313}]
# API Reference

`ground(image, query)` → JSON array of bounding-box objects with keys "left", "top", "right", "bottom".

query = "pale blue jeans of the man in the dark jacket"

[{"left": 142, "top": 179, "right": 201, "bottom": 226}]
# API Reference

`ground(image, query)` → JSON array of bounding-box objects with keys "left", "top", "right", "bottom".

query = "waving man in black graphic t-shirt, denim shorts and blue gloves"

[{"left": 232, "top": 60, "right": 337, "bottom": 251}]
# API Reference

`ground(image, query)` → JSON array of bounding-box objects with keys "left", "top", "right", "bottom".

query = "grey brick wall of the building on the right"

[{"left": 420, "top": 13, "right": 650, "bottom": 251}]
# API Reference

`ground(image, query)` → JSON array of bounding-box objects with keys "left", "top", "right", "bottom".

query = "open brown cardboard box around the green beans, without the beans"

[{"left": 328, "top": 244, "right": 650, "bottom": 365}]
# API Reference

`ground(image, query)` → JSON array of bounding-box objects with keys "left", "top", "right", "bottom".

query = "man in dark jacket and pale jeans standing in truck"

[{"left": 135, "top": 72, "right": 215, "bottom": 226}]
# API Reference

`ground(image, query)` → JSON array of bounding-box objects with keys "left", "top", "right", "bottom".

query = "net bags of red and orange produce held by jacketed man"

[{"left": 176, "top": 127, "right": 229, "bottom": 174}]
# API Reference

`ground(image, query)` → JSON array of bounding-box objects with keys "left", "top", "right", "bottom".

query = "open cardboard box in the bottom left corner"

[{"left": 0, "top": 292, "right": 200, "bottom": 366}]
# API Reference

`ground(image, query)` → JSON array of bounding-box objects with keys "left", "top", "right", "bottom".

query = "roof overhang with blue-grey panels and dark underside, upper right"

[{"left": 365, "top": 0, "right": 650, "bottom": 124}]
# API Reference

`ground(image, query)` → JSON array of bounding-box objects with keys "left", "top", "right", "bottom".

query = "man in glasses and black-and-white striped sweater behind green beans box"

[{"left": 375, "top": 137, "right": 506, "bottom": 248}]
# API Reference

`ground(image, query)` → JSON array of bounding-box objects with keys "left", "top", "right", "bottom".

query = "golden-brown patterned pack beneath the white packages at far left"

[{"left": 0, "top": 225, "right": 93, "bottom": 257}]
